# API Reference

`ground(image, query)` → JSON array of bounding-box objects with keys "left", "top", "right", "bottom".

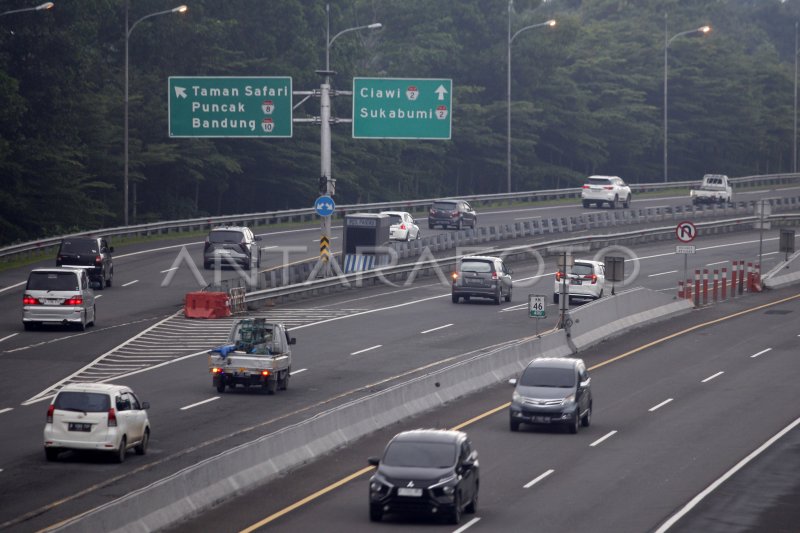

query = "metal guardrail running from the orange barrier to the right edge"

[{"left": 245, "top": 213, "right": 800, "bottom": 304}]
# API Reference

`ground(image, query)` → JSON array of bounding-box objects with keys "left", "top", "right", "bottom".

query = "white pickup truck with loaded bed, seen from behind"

[{"left": 208, "top": 318, "right": 296, "bottom": 394}]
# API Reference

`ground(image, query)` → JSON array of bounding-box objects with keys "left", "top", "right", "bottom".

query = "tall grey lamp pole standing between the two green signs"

[{"left": 317, "top": 4, "right": 382, "bottom": 275}]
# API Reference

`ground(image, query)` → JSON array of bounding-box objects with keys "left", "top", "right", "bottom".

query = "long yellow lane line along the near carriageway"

[{"left": 240, "top": 294, "right": 800, "bottom": 533}]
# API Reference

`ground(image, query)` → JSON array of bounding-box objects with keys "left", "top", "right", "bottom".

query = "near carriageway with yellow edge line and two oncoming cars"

[{"left": 170, "top": 289, "right": 800, "bottom": 533}]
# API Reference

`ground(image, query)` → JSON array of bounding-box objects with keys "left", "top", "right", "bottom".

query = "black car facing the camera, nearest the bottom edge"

[{"left": 369, "top": 429, "right": 480, "bottom": 524}]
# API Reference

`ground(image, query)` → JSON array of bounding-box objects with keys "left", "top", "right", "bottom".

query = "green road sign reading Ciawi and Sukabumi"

[{"left": 353, "top": 78, "right": 453, "bottom": 139}]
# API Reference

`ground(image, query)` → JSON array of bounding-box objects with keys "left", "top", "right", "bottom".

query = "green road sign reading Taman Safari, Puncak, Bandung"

[{"left": 168, "top": 76, "right": 292, "bottom": 137}]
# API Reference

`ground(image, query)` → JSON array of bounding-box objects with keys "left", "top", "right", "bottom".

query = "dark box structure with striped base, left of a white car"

[{"left": 342, "top": 213, "right": 391, "bottom": 274}]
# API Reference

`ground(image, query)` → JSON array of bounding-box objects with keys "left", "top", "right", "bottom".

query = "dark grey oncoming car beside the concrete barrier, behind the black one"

[{"left": 509, "top": 357, "right": 592, "bottom": 433}]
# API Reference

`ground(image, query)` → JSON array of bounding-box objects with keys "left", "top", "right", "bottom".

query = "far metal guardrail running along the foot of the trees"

[{"left": 0, "top": 173, "right": 800, "bottom": 261}]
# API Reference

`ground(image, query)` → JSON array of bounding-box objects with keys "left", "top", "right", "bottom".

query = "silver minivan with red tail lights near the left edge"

[{"left": 22, "top": 267, "right": 95, "bottom": 331}]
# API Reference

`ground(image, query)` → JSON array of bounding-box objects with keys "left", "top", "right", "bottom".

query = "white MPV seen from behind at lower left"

[{"left": 44, "top": 383, "right": 150, "bottom": 463}]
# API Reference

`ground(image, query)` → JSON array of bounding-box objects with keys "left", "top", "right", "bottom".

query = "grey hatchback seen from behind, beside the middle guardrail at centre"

[{"left": 452, "top": 255, "right": 513, "bottom": 305}]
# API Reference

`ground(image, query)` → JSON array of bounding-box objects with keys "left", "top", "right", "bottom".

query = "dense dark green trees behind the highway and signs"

[{"left": 0, "top": 0, "right": 800, "bottom": 244}]
